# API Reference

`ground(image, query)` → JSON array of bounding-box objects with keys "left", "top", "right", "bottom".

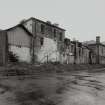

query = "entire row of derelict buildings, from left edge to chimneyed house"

[{"left": 0, "top": 18, "right": 105, "bottom": 65}]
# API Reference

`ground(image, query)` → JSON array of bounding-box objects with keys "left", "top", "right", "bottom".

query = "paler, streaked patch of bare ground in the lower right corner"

[{"left": 59, "top": 71, "right": 105, "bottom": 105}]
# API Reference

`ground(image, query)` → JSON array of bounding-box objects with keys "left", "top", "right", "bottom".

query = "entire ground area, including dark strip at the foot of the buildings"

[{"left": 0, "top": 64, "right": 105, "bottom": 105}]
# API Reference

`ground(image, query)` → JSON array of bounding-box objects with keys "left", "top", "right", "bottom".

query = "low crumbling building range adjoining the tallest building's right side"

[{"left": 62, "top": 38, "right": 90, "bottom": 64}]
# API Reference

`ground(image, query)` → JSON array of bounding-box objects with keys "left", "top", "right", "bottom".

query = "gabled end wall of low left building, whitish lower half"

[{"left": 7, "top": 24, "right": 32, "bottom": 63}]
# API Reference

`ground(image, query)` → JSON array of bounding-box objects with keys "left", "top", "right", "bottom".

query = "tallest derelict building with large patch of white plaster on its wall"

[{"left": 23, "top": 18, "right": 65, "bottom": 63}]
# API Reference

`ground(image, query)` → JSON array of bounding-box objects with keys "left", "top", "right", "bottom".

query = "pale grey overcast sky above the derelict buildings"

[{"left": 0, "top": 0, "right": 105, "bottom": 41}]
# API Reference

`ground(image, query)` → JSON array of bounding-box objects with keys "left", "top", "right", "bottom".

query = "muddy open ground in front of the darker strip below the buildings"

[{"left": 0, "top": 69, "right": 105, "bottom": 105}]
